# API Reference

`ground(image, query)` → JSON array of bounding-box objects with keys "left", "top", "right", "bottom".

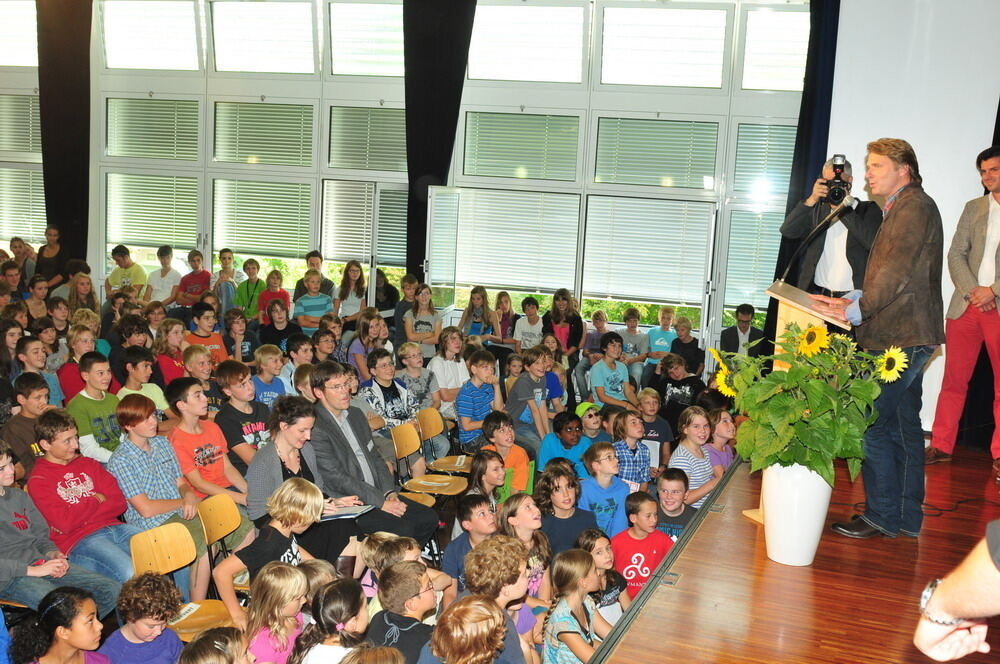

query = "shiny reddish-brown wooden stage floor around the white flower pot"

[{"left": 604, "top": 448, "right": 1000, "bottom": 664}]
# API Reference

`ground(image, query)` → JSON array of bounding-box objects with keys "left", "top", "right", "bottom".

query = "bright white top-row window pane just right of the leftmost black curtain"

[{"left": 101, "top": 0, "right": 200, "bottom": 71}]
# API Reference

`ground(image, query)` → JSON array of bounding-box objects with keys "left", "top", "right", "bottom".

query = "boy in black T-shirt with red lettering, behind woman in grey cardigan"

[{"left": 215, "top": 360, "right": 271, "bottom": 477}]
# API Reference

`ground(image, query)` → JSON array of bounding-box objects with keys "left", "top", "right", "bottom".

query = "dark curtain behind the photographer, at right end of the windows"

[{"left": 764, "top": 0, "right": 840, "bottom": 350}]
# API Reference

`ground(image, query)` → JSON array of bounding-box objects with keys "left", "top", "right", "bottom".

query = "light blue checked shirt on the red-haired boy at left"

[{"left": 108, "top": 434, "right": 187, "bottom": 530}]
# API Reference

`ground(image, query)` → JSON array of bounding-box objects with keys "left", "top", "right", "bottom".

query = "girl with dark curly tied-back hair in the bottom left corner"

[{"left": 10, "top": 585, "right": 111, "bottom": 664}]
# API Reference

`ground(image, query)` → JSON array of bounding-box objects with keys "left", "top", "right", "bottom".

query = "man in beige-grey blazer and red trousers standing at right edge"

[{"left": 924, "top": 146, "right": 1000, "bottom": 474}]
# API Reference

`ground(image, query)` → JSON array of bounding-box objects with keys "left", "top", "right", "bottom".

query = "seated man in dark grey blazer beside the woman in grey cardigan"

[{"left": 310, "top": 360, "right": 438, "bottom": 546}]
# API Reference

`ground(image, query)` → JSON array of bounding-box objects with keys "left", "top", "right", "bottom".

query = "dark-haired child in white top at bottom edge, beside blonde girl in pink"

[{"left": 288, "top": 579, "right": 368, "bottom": 664}]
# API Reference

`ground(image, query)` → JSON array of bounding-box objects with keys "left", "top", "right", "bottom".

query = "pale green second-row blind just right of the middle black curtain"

[{"left": 464, "top": 111, "right": 580, "bottom": 181}]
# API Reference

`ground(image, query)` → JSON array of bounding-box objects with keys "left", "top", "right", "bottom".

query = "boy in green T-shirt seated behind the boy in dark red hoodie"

[{"left": 66, "top": 352, "right": 121, "bottom": 463}]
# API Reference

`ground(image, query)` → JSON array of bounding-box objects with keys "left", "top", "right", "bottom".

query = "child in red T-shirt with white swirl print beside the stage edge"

[{"left": 611, "top": 491, "right": 674, "bottom": 599}]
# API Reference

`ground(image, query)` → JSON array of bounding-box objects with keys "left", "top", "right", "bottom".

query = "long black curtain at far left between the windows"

[{"left": 35, "top": 0, "right": 92, "bottom": 259}]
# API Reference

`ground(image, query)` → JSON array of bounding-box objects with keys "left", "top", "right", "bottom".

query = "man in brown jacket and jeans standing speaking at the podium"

[{"left": 812, "top": 138, "right": 944, "bottom": 539}]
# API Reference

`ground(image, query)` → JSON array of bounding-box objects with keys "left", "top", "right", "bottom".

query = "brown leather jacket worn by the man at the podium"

[{"left": 857, "top": 183, "right": 944, "bottom": 350}]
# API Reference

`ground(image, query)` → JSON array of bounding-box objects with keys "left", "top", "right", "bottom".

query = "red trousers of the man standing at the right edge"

[{"left": 931, "top": 304, "right": 1000, "bottom": 459}]
